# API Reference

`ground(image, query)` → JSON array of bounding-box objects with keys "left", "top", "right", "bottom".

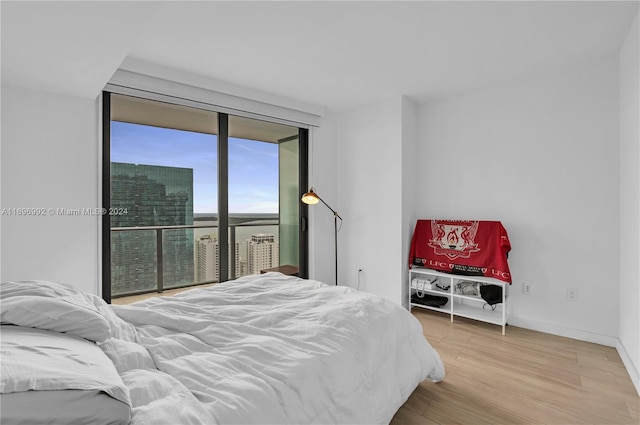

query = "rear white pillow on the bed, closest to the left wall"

[{"left": 0, "top": 280, "right": 111, "bottom": 342}]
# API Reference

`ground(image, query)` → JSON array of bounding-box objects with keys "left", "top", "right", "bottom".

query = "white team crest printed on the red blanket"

[{"left": 427, "top": 220, "right": 480, "bottom": 260}]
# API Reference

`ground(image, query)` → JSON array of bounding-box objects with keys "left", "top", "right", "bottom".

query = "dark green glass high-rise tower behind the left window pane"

[{"left": 110, "top": 162, "right": 194, "bottom": 295}]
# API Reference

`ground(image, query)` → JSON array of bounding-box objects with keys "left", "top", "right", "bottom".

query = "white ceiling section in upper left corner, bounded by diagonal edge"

[{"left": 0, "top": 1, "right": 162, "bottom": 98}]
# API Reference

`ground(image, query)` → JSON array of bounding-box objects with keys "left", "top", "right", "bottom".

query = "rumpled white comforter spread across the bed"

[{"left": 103, "top": 273, "right": 444, "bottom": 425}]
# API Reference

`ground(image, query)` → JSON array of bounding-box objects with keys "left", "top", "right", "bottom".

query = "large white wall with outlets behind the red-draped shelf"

[{"left": 417, "top": 57, "right": 619, "bottom": 345}]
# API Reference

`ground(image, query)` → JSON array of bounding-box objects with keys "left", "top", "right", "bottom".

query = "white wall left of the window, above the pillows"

[{"left": 1, "top": 85, "right": 99, "bottom": 293}]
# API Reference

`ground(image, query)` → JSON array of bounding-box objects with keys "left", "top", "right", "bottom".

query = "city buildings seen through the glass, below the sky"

[{"left": 111, "top": 162, "right": 279, "bottom": 296}]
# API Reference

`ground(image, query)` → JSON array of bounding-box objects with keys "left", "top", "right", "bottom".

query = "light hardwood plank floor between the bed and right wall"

[{"left": 391, "top": 308, "right": 640, "bottom": 425}]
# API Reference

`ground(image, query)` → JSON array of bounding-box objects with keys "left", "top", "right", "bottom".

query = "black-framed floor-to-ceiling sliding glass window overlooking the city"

[{"left": 102, "top": 93, "right": 307, "bottom": 300}]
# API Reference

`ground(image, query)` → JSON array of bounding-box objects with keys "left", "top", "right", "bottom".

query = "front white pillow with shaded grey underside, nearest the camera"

[{"left": 0, "top": 325, "right": 131, "bottom": 424}]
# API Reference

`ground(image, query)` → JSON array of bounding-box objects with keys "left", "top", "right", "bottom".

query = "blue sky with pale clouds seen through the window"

[{"left": 111, "top": 121, "right": 278, "bottom": 213}]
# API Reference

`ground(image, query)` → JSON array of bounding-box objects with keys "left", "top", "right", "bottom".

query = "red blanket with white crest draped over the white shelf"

[{"left": 409, "top": 220, "right": 511, "bottom": 283}]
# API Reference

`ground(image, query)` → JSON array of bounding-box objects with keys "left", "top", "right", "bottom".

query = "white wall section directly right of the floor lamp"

[{"left": 335, "top": 97, "right": 404, "bottom": 304}]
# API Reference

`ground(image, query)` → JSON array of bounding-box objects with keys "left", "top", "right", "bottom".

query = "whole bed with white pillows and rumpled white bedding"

[{"left": 0, "top": 272, "right": 445, "bottom": 425}]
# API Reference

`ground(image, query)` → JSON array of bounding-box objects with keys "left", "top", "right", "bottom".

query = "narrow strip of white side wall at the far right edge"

[{"left": 618, "top": 11, "right": 640, "bottom": 393}]
